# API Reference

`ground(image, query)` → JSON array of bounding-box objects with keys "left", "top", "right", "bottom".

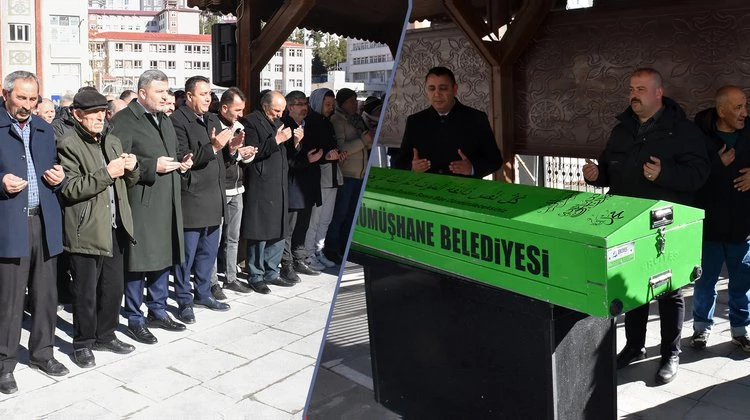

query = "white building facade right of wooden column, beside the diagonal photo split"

[{"left": 346, "top": 38, "right": 393, "bottom": 96}]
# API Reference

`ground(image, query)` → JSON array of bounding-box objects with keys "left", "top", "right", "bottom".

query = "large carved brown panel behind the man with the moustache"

[{"left": 514, "top": 0, "right": 750, "bottom": 157}]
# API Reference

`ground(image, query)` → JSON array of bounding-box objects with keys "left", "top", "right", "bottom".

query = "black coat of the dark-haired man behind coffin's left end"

[{"left": 392, "top": 99, "right": 503, "bottom": 178}]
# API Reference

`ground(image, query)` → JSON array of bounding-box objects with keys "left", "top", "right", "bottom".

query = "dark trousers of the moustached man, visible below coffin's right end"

[{"left": 625, "top": 289, "right": 685, "bottom": 357}]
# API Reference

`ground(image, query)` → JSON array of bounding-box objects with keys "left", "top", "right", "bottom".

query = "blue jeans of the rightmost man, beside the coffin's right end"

[{"left": 693, "top": 241, "right": 750, "bottom": 337}]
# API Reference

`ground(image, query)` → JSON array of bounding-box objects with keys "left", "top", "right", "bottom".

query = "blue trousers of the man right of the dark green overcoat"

[{"left": 174, "top": 225, "right": 221, "bottom": 306}]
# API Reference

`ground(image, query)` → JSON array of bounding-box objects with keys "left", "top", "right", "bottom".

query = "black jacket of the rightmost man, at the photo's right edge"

[{"left": 695, "top": 108, "right": 750, "bottom": 243}]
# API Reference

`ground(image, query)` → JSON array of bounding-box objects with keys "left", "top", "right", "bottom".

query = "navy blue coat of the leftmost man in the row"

[{"left": 0, "top": 106, "right": 65, "bottom": 258}]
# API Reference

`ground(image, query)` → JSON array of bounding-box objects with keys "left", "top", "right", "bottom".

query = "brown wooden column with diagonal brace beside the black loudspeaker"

[{"left": 237, "top": 0, "right": 315, "bottom": 113}]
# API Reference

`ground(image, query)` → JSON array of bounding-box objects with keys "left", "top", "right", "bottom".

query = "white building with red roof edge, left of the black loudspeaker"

[{"left": 90, "top": 32, "right": 211, "bottom": 95}]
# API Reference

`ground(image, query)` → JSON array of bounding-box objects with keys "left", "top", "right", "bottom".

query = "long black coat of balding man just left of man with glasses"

[{"left": 240, "top": 110, "right": 292, "bottom": 241}]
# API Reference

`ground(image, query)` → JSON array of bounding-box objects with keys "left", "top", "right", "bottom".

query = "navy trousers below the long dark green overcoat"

[{"left": 123, "top": 267, "right": 171, "bottom": 326}]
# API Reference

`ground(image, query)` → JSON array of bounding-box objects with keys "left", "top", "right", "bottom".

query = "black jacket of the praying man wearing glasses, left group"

[{"left": 281, "top": 115, "right": 324, "bottom": 210}]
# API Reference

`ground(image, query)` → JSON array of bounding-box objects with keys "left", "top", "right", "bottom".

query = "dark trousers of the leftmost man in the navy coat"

[{"left": 0, "top": 216, "right": 57, "bottom": 373}]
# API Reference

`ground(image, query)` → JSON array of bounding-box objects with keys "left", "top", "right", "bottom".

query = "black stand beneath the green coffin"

[{"left": 350, "top": 251, "right": 617, "bottom": 420}]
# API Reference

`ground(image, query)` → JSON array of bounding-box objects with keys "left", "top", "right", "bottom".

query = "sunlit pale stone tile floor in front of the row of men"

[{"left": 0, "top": 267, "right": 339, "bottom": 420}]
